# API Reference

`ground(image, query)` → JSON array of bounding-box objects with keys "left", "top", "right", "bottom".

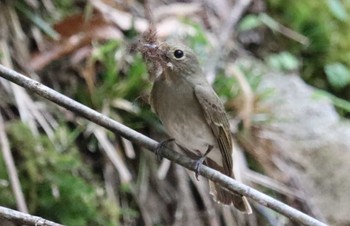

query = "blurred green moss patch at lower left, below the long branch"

[{"left": 0, "top": 122, "right": 120, "bottom": 226}]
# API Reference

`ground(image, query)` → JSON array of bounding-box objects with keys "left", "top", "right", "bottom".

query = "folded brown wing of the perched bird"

[{"left": 194, "top": 85, "right": 233, "bottom": 175}]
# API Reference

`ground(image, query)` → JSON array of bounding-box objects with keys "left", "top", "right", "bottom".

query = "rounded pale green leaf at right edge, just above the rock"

[{"left": 325, "top": 63, "right": 350, "bottom": 89}]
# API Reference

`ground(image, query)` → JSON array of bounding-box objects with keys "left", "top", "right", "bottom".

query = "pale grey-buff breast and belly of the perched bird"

[{"left": 154, "top": 77, "right": 222, "bottom": 165}]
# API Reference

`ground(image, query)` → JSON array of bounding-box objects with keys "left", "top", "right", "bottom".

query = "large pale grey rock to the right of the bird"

[{"left": 251, "top": 73, "right": 350, "bottom": 226}]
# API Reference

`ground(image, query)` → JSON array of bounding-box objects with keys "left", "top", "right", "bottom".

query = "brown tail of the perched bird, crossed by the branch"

[{"left": 207, "top": 161, "right": 252, "bottom": 214}]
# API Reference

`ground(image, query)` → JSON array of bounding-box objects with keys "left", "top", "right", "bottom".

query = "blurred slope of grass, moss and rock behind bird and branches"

[{"left": 0, "top": 0, "right": 350, "bottom": 226}]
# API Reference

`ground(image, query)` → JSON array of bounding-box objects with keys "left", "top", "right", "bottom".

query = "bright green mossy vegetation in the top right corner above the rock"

[{"left": 268, "top": 0, "right": 350, "bottom": 95}]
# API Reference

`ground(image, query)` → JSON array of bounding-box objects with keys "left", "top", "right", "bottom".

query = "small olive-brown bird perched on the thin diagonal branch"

[{"left": 143, "top": 42, "right": 251, "bottom": 213}]
